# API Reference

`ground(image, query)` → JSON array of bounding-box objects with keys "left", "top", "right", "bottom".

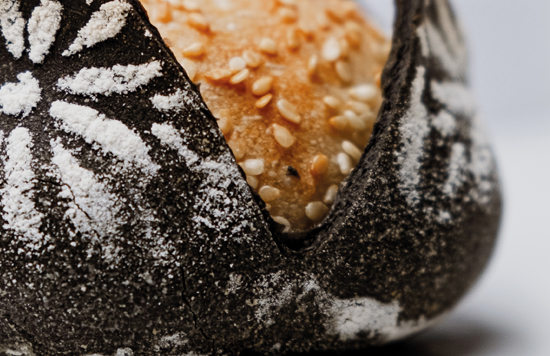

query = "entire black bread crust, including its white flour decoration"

[{"left": 0, "top": 0, "right": 501, "bottom": 356}]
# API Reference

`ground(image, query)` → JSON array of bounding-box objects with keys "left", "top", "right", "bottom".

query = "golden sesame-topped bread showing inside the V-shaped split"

[{"left": 142, "top": 0, "right": 389, "bottom": 231}]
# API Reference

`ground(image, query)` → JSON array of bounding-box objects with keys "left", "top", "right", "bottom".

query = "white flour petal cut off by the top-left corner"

[{"left": 0, "top": 0, "right": 25, "bottom": 59}]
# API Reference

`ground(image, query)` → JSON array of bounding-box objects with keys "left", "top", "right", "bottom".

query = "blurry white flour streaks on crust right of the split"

[{"left": 397, "top": 6, "right": 493, "bottom": 214}]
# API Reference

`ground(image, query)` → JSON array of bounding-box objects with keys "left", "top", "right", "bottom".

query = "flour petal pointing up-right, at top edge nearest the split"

[{"left": 63, "top": 0, "right": 132, "bottom": 56}]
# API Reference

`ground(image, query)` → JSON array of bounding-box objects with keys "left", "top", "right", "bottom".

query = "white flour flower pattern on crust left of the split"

[{"left": 0, "top": 0, "right": 171, "bottom": 261}]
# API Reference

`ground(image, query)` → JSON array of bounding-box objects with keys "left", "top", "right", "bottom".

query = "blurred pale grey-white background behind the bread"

[{"left": 361, "top": 0, "right": 550, "bottom": 356}]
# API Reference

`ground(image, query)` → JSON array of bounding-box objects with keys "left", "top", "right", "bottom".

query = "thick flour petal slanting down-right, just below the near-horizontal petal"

[{"left": 50, "top": 101, "right": 159, "bottom": 174}]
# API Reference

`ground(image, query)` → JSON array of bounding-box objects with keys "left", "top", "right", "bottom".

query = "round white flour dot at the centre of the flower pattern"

[{"left": 0, "top": 72, "right": 42, "bottom": 117}]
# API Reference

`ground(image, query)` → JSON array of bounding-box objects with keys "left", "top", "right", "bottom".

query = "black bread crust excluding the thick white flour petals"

[{"left": 0, "top": 0, "right": 501, "bottom": 355}]
